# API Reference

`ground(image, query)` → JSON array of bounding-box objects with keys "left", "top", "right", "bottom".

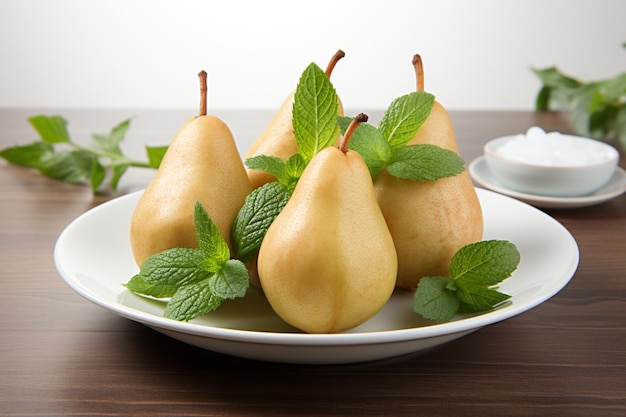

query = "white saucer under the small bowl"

[{"left": 468, "top": 156, "right": 626, "bottom": 208}]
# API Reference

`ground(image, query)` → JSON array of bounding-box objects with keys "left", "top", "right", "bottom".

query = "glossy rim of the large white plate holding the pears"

[{"left": 53, "top": 188, "right": 580, "bottom": 346}]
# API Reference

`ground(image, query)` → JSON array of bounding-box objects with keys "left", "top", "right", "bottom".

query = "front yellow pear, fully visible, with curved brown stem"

[{"left": 258, "top": 114, "right": 397, "bottom": 333}]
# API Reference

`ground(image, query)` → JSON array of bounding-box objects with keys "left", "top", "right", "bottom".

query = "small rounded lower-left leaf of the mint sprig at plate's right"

[{"left": 413, "top": 277, "right": 459, "bottom": 321}]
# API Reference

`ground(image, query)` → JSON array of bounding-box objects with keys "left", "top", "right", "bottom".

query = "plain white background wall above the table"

[{"left": 0, "top": 0, "right": 626, "bottom": 110}]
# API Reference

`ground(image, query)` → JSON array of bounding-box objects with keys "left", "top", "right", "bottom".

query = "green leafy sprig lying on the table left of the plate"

[{"left": 0, "top": 115, "right": 167, "bottom": 192}]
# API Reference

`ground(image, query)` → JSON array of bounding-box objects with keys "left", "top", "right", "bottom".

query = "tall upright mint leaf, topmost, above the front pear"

[{"left": 292, "top": 63, "right": 339, "bottom": 161}]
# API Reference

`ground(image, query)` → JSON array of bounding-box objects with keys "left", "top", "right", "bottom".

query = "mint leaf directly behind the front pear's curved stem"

[{"left": 337, "top": 116, "right": 392, "bottom": 178}]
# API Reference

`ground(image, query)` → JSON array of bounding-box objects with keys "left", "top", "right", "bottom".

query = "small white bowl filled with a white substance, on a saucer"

[{"left": 484, "top": 127, "right": 619, "bottom": 197}]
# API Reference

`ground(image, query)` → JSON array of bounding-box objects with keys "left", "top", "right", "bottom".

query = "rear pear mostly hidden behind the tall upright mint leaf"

[{"left": 244, "top": 49, "right": 345, "bottom": 189}]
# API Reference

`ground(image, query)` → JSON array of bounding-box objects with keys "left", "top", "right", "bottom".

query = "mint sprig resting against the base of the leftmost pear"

[{"left": 125, "top": 202, "right": 250, "bottom": 321}]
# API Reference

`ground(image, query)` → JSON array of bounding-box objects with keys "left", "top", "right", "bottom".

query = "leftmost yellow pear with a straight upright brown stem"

[{"left": 130, "top": 71, "right": 252, "bottom": 266}]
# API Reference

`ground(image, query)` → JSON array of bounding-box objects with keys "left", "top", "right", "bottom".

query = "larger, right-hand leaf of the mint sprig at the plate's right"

[{"left": 450, "top": 240, "right": 520, "bottom": 286}]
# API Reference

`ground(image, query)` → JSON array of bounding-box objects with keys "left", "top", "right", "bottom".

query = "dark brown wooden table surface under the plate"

[{"left": 0, "top": 109, "right": 626, "bottom": 417}]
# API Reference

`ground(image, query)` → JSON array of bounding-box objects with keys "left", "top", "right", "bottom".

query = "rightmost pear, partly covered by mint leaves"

[{"left": 374, "top": 55, "right": 483, "bottom": 290}]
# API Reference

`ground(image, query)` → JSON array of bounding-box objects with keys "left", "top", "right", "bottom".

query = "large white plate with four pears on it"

[{"left": 54, "top": 189, "right": 579, "bottom": 364}]
